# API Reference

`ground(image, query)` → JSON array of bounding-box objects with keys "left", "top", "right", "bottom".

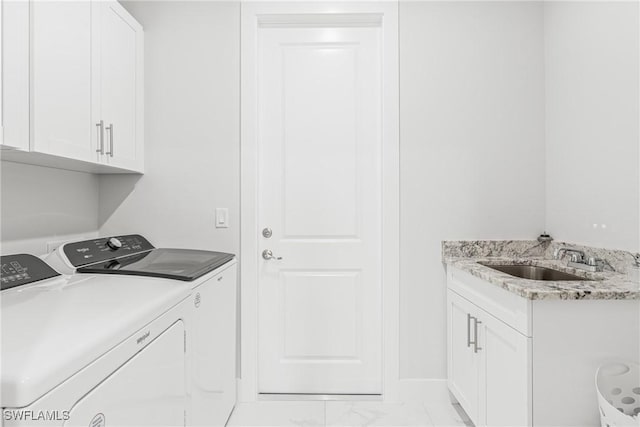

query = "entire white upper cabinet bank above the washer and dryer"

[{"left": 2, "top": 0, "right": 144, "bottom": 173}]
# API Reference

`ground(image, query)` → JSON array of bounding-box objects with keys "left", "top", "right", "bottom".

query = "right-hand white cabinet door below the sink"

[{"left": 478, "top": 313, "right": 531, "bottom": 426}]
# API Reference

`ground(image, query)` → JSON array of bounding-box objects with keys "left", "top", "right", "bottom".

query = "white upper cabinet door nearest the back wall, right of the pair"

[{"left": 94, "top": 1, "right": 144, "bottom": 171}]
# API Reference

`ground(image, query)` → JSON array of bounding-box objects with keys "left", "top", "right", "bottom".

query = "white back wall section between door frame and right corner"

[{"left": 400, "top": 2, "right": 545, "bottom": 378}]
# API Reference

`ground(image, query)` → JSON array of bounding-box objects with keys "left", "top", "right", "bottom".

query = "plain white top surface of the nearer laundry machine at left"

[{"left": 0, "top": 276, "right": 189, "bottom": 408}]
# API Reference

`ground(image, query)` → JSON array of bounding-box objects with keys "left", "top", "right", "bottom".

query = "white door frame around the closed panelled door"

[{"left": 238, "top": 0, "right": 400, "bottom": 402}]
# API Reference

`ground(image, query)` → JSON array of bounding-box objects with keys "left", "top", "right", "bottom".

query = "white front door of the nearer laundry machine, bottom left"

[{"left": 64, "top": 321, "right": 186, "bottom": 427}]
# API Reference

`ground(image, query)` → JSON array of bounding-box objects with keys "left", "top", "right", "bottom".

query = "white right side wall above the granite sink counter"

[{"left": 545, "top": 1, "right": 640, "bottom": 252}]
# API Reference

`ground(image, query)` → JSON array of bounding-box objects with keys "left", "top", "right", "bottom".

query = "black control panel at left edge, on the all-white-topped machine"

[{"left": 0, "top": 254, "right": 60, "bottom": 291}]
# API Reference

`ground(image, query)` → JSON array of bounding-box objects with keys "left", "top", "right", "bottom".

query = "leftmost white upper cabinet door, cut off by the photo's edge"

[{"left": 0, "top": 1, "right": 29, "bottom": 150}]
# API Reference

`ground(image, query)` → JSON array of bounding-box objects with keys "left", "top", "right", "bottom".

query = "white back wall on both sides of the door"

[{"left": 109, "top": 2, "right": 544, "bottom": 378}]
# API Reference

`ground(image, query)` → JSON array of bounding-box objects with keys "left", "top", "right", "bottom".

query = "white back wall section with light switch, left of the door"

[{"left": 99, "top": 1, "right": 240, "bottom": 253}]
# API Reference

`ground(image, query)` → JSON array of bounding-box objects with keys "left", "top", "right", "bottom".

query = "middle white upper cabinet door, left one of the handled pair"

[{"left": 31, "top": 1, "right": 96, "bottom": 161}]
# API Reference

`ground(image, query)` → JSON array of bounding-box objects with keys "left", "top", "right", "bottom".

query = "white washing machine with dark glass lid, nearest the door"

[{"left": 46, "top": 234, "right": 237, "bottom": 427}]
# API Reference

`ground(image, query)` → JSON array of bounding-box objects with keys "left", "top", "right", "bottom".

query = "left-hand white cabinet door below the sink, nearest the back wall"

[{"left": 447, "top": 291, "right": 479, "bottom": 425}]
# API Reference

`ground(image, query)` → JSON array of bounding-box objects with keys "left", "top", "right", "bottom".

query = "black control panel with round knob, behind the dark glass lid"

[{"left": 63, "top": 234, "right": 154, "bottom": 267}]
